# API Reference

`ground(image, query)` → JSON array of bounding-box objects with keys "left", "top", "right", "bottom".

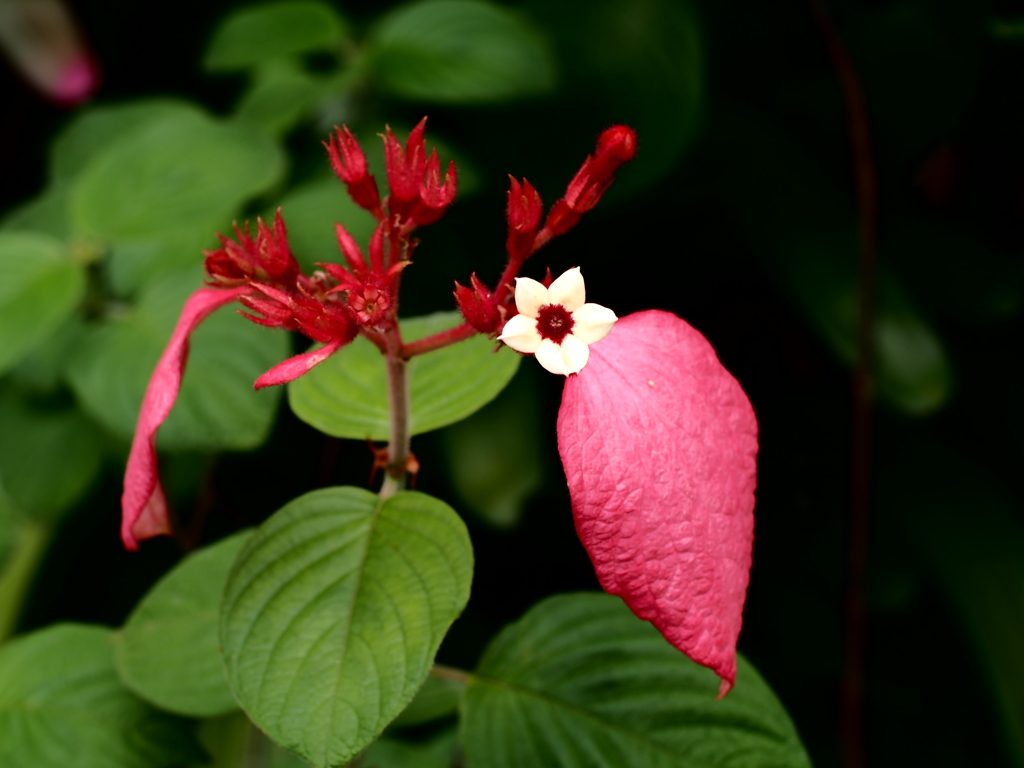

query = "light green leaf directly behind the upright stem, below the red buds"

[{"left": 288, "top": 312, "right": 520, "bottom": 440}]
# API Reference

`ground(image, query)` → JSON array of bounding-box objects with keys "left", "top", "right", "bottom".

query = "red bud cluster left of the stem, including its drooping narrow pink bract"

[{"left": 121, "top": 118, "right": 456, "bottom": 549}]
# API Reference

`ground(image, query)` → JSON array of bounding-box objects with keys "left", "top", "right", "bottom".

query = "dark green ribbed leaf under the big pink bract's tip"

[{"left": 461, "top": 593, "right": 810, "bottom": 768}]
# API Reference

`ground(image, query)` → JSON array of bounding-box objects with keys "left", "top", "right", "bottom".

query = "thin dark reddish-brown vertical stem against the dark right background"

[{"left": 809, "top": 0, "right": 878, "bottom": 768}]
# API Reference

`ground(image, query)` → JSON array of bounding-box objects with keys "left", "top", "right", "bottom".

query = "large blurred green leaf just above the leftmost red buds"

[{"left": 71, "top": 103, "right": 285, "bottom": 294}]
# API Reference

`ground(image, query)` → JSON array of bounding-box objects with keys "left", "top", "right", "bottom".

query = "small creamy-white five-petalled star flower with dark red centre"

[{"left": 498, "top": 267, "right": 618, "bottom": 376}]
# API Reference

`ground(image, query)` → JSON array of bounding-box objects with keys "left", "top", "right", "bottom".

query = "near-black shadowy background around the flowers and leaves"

[{"left": 0, "top": 0, "right": 1024, "bottom": 766}]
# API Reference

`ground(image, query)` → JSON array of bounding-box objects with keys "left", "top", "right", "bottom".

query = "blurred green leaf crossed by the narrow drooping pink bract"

[{"left": 68, "top": 270, "right": 289, "bottom": 451}]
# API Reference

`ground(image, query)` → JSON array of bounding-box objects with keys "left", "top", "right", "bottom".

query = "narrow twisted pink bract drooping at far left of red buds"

[{"left": 121, "top": 286, "right": 249, "bottom": 550}]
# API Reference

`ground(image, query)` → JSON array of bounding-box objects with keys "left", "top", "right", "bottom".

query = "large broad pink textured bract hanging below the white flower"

[{"left": 558, "top": 310, "right": 758, "bottom": 696}]
